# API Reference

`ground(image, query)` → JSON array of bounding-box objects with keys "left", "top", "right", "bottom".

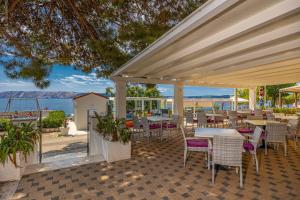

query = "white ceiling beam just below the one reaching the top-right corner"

[{"left": 156, "top": 21, "right": 300, "bottom": 77}]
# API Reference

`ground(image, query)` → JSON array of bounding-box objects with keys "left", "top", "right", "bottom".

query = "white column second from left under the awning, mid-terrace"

[{"left": 174, "top": 82, "right": 183, "bottom": 124}]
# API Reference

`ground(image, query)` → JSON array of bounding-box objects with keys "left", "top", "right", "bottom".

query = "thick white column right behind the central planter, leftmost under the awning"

[{"left": 115, "top": 80, "right": 126, "bottom": 119}]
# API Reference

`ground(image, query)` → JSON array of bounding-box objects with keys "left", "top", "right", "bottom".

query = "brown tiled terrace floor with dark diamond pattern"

[{"left": 10, "top": 134, "right": 300, "bottom": 200}]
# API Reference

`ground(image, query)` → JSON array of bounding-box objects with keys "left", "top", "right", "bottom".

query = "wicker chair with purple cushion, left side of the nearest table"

[{"left": 180, "top": 126, "right": 208, "bottom": 167}]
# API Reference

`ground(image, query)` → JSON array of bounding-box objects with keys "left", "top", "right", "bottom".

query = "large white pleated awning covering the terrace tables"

[{"left": 112, "top": 0, "right": 300, "bottom": 88}]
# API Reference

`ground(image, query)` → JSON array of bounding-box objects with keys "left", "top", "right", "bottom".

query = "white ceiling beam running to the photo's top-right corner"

[{"left": 135, "top": 0, "right": 300, "bottom": 77}]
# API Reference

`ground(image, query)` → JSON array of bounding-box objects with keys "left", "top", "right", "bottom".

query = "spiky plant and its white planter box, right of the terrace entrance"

[{"left": 90, "top": 113, "right": 131, "bottom": 162}]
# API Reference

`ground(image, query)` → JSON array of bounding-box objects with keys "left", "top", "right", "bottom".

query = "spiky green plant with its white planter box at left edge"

[{"left": 0, "top": 123, "right": 39, "bottom": 181}]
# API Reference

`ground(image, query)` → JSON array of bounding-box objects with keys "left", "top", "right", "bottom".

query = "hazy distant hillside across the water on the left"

[{"left": 0, "top": 91, "right": 78, "bottom": 99}]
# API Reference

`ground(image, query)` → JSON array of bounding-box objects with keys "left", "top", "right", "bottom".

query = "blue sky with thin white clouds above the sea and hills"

[{"left": 0, "top": 65, "right": 233, "bottom": 96}]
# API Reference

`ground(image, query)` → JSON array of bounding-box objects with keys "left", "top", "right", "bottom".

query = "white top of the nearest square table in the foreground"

[{"left": 195, "top": 128, "right": 244, "bottom": 139}]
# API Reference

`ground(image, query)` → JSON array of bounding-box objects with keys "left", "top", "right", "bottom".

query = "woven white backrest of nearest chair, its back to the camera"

[{"left": 212, "top": 136, "right": 243, "bottom": 166}]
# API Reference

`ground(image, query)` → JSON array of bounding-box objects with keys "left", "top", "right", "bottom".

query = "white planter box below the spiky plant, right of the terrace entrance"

[{"left": 89, "top": 129, "right": 131, "bottom": 162}]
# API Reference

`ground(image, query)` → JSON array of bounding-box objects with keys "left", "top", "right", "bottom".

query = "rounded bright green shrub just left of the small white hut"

[{"left": 42, "top": 110, "right": 66, "bottom": 128}]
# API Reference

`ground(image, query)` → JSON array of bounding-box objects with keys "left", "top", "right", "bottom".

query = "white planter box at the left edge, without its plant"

[{"left": 0, "top": 145, "right": 39, "bottom": 182}]
